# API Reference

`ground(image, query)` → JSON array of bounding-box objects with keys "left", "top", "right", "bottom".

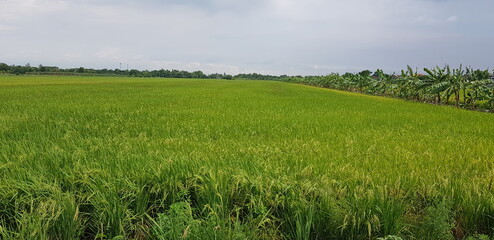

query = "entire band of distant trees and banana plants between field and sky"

[{"left": 0, "top": 63, "right": 494, "bottom": 112}]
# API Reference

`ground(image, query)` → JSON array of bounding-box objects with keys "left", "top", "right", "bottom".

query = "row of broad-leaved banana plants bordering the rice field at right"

[{"left": 283, "top": 65, "right": 494, "bottom": 111}]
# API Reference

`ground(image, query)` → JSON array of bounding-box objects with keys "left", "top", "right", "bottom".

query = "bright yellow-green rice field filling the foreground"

[{"left": 0, "top": 76, "right": 494, "bottom": 239}]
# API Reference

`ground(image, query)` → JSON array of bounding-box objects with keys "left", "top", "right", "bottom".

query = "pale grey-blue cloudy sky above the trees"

[{"left": 0, "top": 0, "right": 494, "bottom": 75}]
